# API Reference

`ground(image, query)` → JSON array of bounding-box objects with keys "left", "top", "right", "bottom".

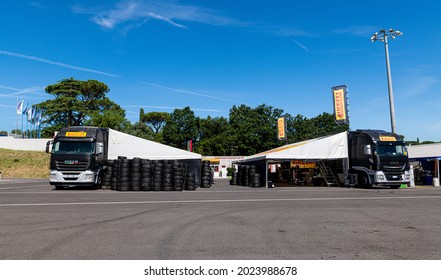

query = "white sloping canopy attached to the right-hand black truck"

[{"left": 238, "top": 131, "right": 348, "bottom": 163}]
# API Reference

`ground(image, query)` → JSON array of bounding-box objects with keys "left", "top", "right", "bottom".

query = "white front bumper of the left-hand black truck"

[{"left": 49, "top": 170, "right": 96, "bottom": 187}]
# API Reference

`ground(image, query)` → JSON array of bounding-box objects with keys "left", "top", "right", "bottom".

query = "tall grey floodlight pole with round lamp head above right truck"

[{"left": 371, "top": 29, "right": 403, "bottom": 133}]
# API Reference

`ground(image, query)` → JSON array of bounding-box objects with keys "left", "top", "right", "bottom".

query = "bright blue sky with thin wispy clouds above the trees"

[{"left": 0, "top": 0, "right": 441, "bottom": 141}]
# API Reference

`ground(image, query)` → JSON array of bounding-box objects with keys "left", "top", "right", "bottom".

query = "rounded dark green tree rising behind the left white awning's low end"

[{"left": 163, "top": 107, "right": 198, "bottom": 149}]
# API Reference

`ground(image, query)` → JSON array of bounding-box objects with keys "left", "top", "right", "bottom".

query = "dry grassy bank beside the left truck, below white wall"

[{"left": 0, "top": 148, "right": 50, "bottom": 178}]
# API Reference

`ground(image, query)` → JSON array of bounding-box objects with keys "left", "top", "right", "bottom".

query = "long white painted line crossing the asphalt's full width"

[{"left": 0, "top": 195, "right": 441, "bottom": 207}]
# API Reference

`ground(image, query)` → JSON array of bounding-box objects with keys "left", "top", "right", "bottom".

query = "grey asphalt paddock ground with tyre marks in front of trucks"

[{"left": 0, "top": 179, "right": 441, "bottom": 260}]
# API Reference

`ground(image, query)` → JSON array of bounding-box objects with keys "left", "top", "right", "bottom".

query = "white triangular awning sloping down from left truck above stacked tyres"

[{"left": 108, "top": 129, "right": 202, "bottom": 160}]
